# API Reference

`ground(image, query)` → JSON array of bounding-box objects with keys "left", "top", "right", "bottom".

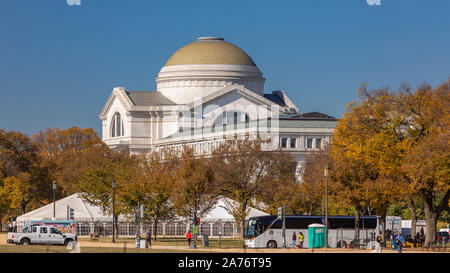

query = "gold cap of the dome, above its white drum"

[{"left": 165, "top": 37, "right": 256, "bottom": 66}]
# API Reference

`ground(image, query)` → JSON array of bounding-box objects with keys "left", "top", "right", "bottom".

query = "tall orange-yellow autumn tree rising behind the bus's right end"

[{"left": 331, "top": 85, "right": 406, "bottom": 242}]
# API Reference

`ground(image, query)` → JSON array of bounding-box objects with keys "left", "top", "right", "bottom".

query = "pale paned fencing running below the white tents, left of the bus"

[{"left": 77, "top": 222, "right": 241, "bottom": 238}]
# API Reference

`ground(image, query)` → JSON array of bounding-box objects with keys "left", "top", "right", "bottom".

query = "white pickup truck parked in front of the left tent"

[{"left": 7, "top": 226, "right": 78, "bottom": 245}]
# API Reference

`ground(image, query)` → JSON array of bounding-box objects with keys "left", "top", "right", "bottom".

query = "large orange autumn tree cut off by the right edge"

[{"left": 384, "top": 80, "right": 450, "bottom": 243}]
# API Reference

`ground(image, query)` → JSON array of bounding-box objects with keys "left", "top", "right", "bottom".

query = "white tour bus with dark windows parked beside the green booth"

[{"left": 245, "top": 215, "right": 379, "bottom": 248}]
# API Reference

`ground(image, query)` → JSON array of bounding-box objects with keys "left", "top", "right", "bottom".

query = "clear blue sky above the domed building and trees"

[{"left": 0, "top": 0, "right": 450, "bottom": 135}]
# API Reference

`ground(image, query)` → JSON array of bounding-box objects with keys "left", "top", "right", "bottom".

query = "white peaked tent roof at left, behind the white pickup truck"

[{"left": 16, "top": 193, "right": 121, "bottom": 224}]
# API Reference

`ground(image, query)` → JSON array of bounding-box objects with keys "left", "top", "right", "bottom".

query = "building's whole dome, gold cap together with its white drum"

[{"left": 156, "top": 37, "right": 264, "bottom": 104}]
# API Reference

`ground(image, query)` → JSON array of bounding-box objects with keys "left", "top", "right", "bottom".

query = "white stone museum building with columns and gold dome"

[{"left": 100, "top": 37, "right": 336, "bottom": 176}]
